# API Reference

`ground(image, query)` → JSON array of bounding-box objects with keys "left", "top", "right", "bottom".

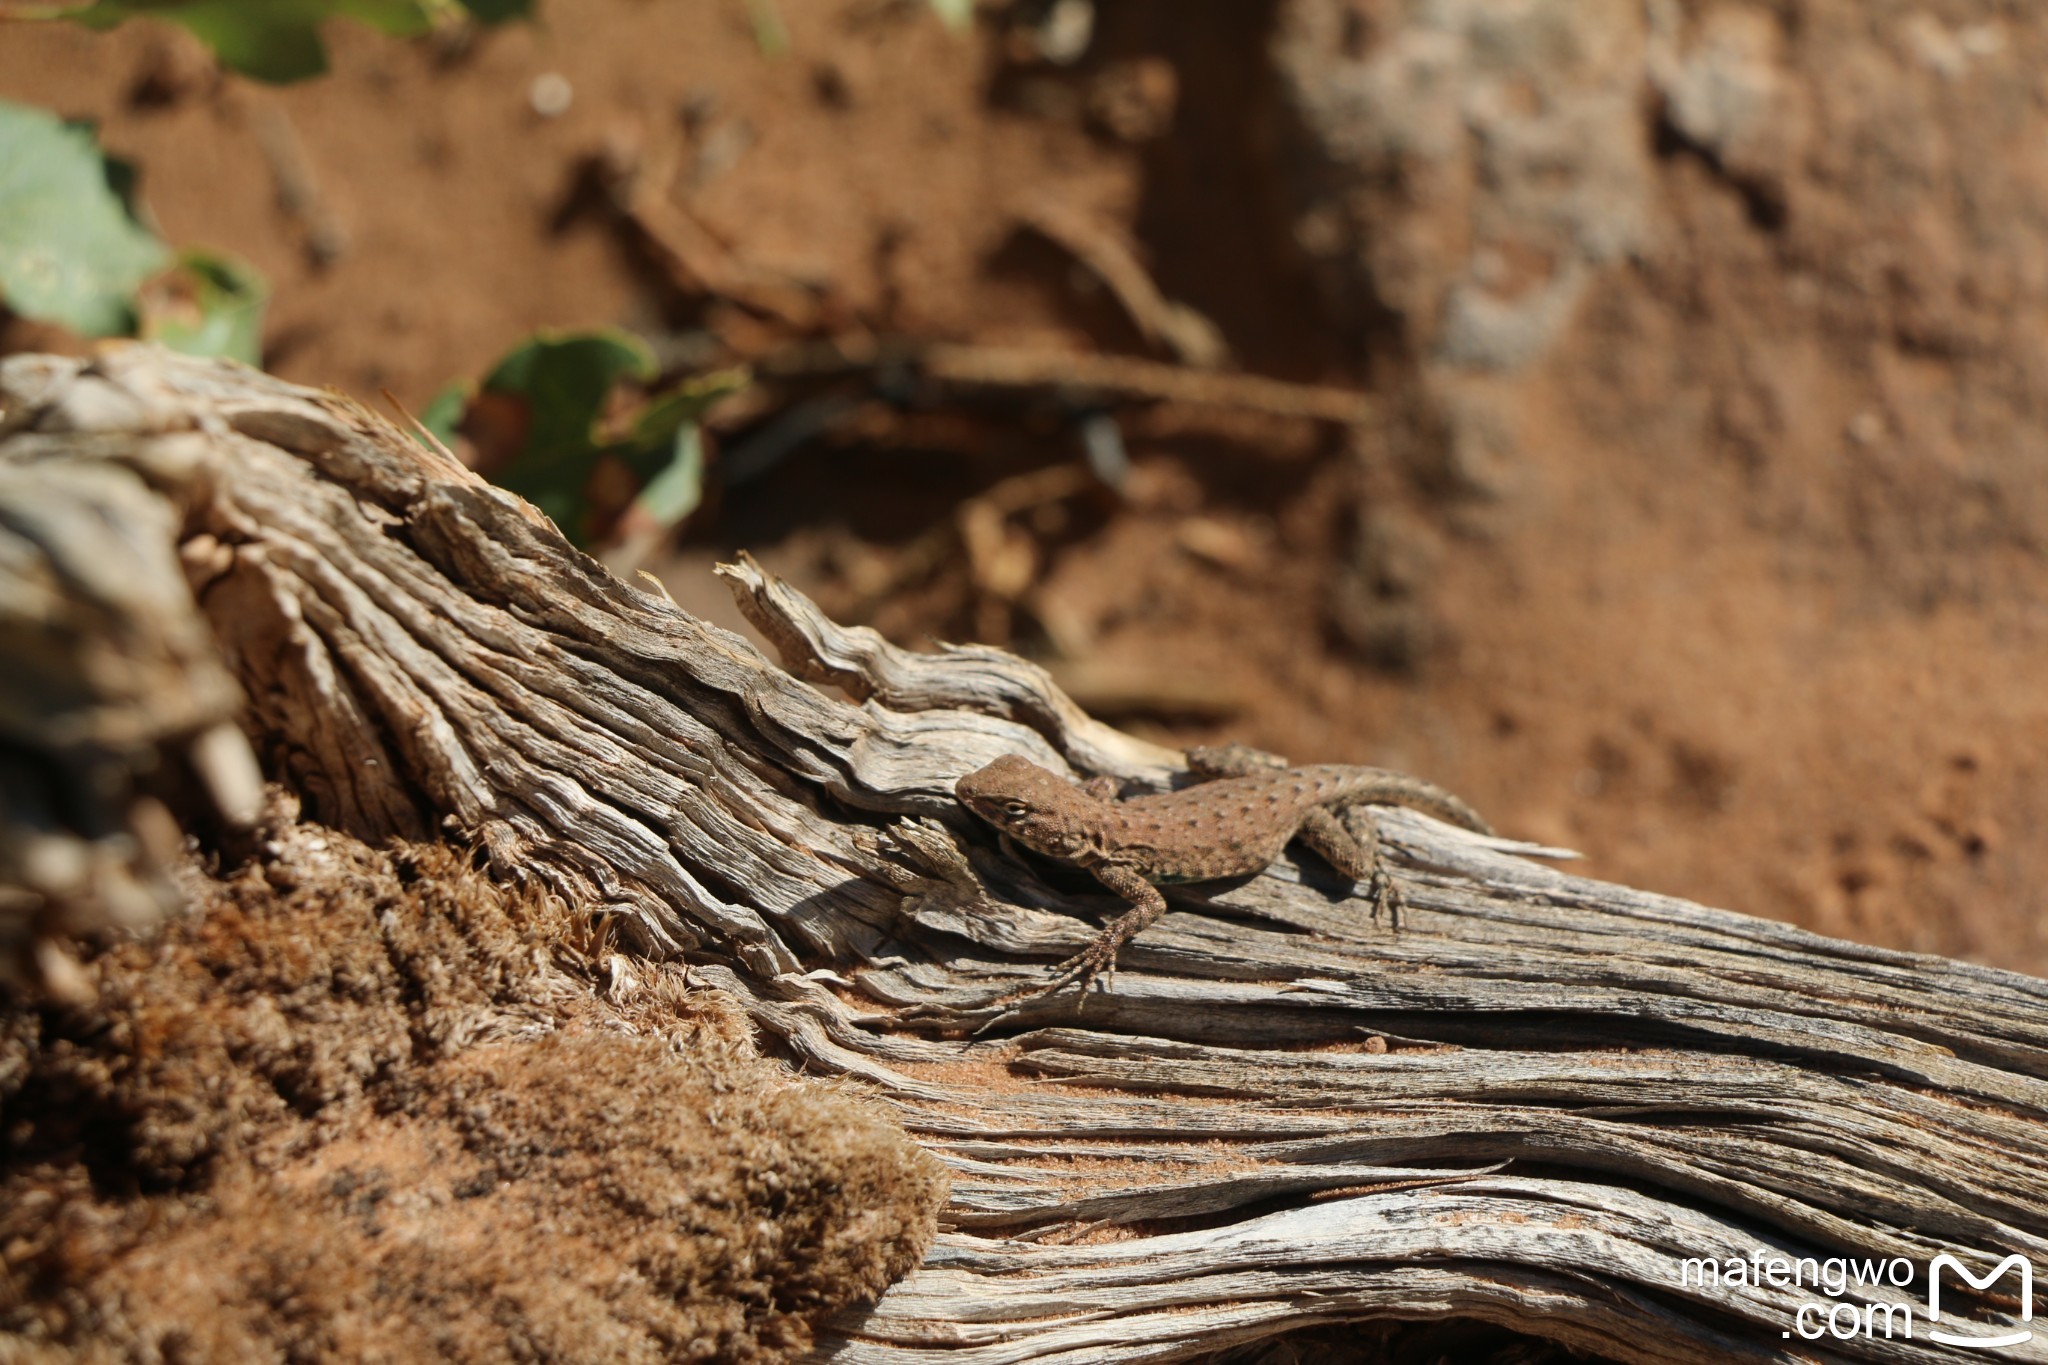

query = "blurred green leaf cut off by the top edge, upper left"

[{"left": 70, "top": 0, "right": 434, "bottom": 84}]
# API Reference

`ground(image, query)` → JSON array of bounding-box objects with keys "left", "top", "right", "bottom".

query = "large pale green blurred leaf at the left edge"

[{"left": 0, "top": 102, "right": 170, "bottom": 336}]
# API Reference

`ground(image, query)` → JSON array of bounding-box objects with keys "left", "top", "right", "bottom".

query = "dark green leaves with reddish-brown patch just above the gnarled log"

[{"left": 420, "top": 332, "right": 748, "bottom": 544}]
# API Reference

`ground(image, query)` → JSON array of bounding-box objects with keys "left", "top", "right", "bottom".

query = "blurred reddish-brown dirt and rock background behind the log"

[{"left": 0, "top": 0, "right": 2048, "bottom": 972}]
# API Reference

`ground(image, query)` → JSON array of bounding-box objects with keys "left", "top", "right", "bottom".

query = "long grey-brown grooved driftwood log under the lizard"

[{"left": 0, "top": 348, "right": 2048, "bottom": 1365}]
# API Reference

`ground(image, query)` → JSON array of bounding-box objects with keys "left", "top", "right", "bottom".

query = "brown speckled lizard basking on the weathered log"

[{"left": 952, "top": 745, "right": 1493, "bottom": 995}]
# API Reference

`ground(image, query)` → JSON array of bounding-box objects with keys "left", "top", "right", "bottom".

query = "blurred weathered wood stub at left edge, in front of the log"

[{"left": 0, "top": 356, "right": 262, "bottom": 1001}]
